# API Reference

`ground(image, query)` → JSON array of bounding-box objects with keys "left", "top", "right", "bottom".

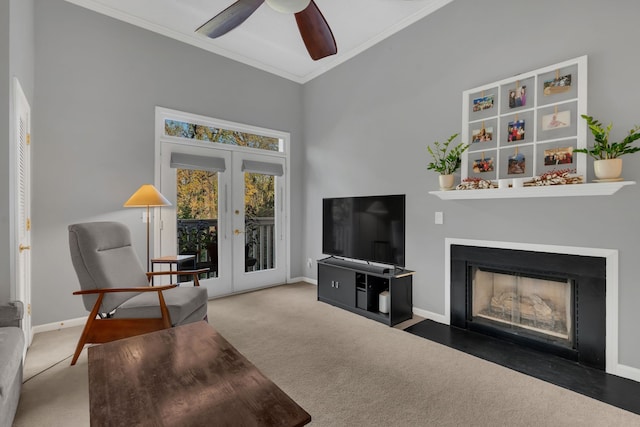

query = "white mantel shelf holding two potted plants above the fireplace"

[{"left": 429, "top": 181, "right": 636, "bottom": 200}]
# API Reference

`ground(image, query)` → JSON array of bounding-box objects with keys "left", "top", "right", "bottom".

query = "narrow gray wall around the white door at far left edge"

[{"left": 0, "top": 0, "right": 34, "bottom": 302}]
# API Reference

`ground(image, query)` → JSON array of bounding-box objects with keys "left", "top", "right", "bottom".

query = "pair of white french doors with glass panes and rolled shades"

[{"left": 156, "top": 142, "right": 286, "bottom": 297}]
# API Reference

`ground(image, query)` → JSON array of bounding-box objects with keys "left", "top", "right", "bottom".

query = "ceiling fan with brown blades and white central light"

[{"left": 196, "top": 0, "right": 338, "bottom": 61}]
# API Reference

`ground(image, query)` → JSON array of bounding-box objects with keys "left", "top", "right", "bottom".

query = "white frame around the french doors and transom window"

[{"left": 151, "top": 106, "right": 291, "bottom": 293}]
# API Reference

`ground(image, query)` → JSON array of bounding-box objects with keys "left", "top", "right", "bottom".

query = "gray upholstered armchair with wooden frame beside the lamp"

[{"left": 69, "top": 222, "right": 208, "bottom": 365}]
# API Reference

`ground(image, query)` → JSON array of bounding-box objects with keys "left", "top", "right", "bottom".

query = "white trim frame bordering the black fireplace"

[{"left": 442, "top": 238, "right": 624, "bottom": 381}]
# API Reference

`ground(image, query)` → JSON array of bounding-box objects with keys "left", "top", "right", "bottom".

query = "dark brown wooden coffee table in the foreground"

[{"left": 89, "top": 321, "right": 311, "bottom": 426}]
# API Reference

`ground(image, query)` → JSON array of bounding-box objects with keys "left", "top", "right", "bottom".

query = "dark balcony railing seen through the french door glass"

[{"left": 177, "top": 217, "right": 275, "bottom": 276}]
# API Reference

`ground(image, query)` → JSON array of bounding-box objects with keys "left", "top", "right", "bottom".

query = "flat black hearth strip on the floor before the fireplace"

[{"left": 405, "top": 320, "right": 640, "bottom": 415}]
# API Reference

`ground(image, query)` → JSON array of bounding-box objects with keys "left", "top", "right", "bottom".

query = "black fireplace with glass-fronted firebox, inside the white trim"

[{"left": 450, "top": 244, "right": 607, "bottom": 370}]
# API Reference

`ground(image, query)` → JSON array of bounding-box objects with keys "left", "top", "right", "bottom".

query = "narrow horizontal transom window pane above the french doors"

[{"left": 164, "top": 119, "right": 282, "bottom": 151}]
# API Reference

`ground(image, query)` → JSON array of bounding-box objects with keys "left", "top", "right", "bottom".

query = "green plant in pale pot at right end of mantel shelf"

[{"left": 573, "top": 114, "right": 640, "bottom": 181}]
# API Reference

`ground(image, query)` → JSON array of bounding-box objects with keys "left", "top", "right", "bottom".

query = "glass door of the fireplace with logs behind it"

[{"left": 469, "top": 267, "right": 575, "bottom": 348}]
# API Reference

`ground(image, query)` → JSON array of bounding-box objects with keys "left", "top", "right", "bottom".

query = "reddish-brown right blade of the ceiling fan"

[{"left": 296, "top": 0, "right": 338, "bottom": 61}]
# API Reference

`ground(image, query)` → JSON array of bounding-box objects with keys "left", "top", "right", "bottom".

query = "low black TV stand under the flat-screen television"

[{"left": 318, "top": 257, "right": 414, "bottom": 326}]
